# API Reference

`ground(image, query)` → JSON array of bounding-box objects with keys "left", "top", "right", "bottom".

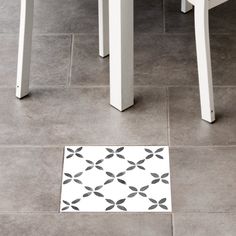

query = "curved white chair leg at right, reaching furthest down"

[{"left": 195, "top": 0, "right": 215, "bottom": 123}]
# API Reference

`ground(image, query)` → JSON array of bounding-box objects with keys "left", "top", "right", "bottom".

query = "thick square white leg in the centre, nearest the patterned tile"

[{"left": 109, "top": 0, "right": 134, "bottom": 111}]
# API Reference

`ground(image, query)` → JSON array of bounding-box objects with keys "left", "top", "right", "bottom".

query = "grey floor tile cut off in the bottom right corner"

[{"left": 174, "top": 213, "right": 236, "bottom": 236}]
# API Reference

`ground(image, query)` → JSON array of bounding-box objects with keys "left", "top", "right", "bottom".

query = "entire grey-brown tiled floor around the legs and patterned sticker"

[{"left": 0, "top": 0, "right": 236, "bottom": 236}]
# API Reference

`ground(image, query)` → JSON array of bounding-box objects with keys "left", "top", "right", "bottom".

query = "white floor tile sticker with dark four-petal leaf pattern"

[{"left": 60, "top": 146, "right": 171, "bottom": 212}]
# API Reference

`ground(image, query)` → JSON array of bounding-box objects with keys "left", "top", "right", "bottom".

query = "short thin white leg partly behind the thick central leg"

[{"left": 98, "top": 0, "right": 109, "bottom": 57}]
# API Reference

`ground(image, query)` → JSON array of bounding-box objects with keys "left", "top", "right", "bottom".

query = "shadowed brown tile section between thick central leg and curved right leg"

[{"left": 134, "top": 34, "right": 198, "bottom": 86}]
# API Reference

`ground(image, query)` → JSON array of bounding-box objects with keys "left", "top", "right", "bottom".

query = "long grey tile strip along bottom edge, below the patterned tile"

[{"left": 0, "top": 214, "right": 172, "bottom": 236}]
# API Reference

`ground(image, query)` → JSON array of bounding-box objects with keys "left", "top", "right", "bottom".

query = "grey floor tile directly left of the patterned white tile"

[{"left": 0, "top": 148, "right": 63, "bottom": 212}]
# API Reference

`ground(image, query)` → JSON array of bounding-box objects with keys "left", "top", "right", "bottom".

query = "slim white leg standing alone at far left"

[{"left": 16, "top": 0, "right": 34, "bottom": 98}]
